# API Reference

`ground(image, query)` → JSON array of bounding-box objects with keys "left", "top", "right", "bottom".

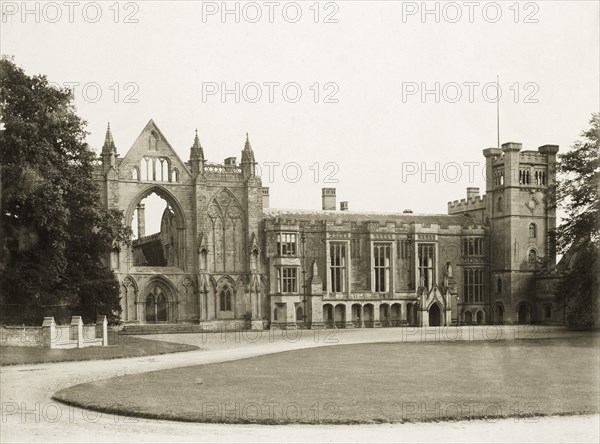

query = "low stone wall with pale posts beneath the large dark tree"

[{"left": 0, "top": 316, "right": 108, "bottom": 348}]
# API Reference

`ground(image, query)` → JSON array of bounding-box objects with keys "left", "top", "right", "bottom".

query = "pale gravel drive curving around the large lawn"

[{"left": 0, "top": 326, "right": 600, "bottom": 442}]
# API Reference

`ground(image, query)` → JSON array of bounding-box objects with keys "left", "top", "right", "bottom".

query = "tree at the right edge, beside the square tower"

[{"left": 556, "top": 114, "right": 600, "bottom": 327}]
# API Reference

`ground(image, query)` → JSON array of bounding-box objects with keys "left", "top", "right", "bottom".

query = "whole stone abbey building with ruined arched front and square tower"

[{"left": 95, "top": 120, "right": 563, "bottom": 329}]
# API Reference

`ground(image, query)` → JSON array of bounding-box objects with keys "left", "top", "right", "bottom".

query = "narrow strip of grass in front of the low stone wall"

[{"left": 0, "top": 332, "right": 198, "bottom": 365}]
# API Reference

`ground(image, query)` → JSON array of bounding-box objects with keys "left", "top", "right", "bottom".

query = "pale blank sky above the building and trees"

[{"left": 0, "top": 1, "right": 600, "bottom": 213}]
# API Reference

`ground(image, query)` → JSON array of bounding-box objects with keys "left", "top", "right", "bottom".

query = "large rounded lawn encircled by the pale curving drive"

[{"left": 54, "top": 335, "right": 599, "bottom": 424}]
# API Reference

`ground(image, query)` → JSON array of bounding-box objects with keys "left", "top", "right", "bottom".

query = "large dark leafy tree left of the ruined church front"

[{"left": 0, "top": 58, "right": 128, "bottom": 323}]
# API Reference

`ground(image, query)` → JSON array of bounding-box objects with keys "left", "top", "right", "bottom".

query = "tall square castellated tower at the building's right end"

[{"left": 483, "top": 142, "right": 558, "bottom": 323}]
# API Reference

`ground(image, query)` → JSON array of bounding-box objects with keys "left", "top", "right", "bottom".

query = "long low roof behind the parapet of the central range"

[{"left": 263, "top": 208, "right": 481, "bottom": 228}]
